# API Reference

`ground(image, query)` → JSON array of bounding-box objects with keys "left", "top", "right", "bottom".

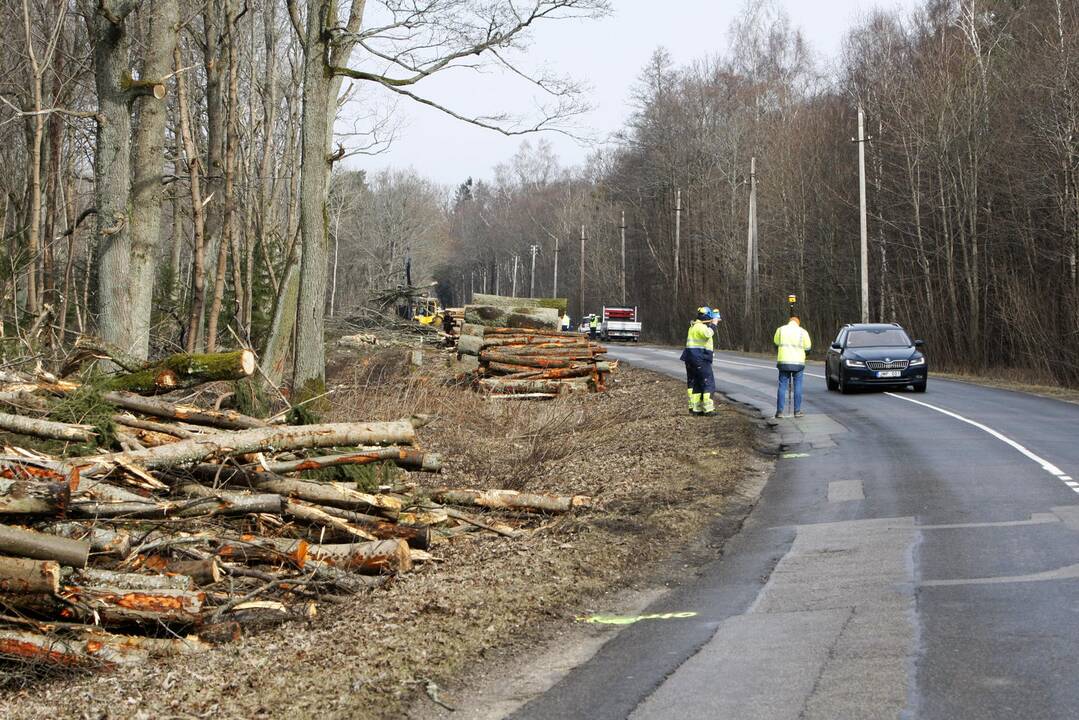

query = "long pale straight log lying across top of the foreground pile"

[{"left": 65, "top": 421, "right": 415, "bottom": 476}]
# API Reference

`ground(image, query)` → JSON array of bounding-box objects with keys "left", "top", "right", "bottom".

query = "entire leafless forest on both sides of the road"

[{"left": 0, "top": 0, "right": 1079, "bottom": 390}]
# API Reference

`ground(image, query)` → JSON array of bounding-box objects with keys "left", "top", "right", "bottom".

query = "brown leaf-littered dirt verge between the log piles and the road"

[{"left": 0, "top": 351, "right": 766, "bottom": 720}]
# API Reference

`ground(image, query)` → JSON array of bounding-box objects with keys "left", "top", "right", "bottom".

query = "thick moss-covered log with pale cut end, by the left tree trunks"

[{"left": 108, "top": 350, "right": 256, "bottom": 395}]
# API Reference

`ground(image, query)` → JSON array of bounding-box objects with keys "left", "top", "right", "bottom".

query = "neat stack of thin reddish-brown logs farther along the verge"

[{"left": 457, "top": 325, "right": 617, "bottom": 399}]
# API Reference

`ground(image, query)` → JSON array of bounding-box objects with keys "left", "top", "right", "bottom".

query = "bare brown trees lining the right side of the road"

[{"left": 439, "top": 0, "right": 1079, "bottom": 385}]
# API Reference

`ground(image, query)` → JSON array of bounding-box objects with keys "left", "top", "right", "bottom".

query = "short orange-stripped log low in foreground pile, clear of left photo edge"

[{"left": 60, "top": 585, "right": 206, "bottom": 625}]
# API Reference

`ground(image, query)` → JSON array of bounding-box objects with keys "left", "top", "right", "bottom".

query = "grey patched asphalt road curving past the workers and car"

[{"left": 513, "top": 347, "right": 1079, "bottom": 720}]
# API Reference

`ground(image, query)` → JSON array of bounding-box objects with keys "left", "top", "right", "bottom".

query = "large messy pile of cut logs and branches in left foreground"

[{"left": 0, "top": 343, "right": 590, "bottom": 668}]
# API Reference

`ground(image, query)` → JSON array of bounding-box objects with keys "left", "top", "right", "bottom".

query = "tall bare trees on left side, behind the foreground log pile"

[{"left": 0, "top": 0, "right": 610, "bottom": 392}]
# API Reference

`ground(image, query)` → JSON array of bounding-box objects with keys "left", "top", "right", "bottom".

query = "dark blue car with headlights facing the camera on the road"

[{"left": 824, "top": 323, "right": 929, "bottom": 393}]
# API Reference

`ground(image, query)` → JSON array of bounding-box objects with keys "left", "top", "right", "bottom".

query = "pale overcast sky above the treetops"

[{"left": 338, "top": 0, "right": 916, "bottom": 186}]
